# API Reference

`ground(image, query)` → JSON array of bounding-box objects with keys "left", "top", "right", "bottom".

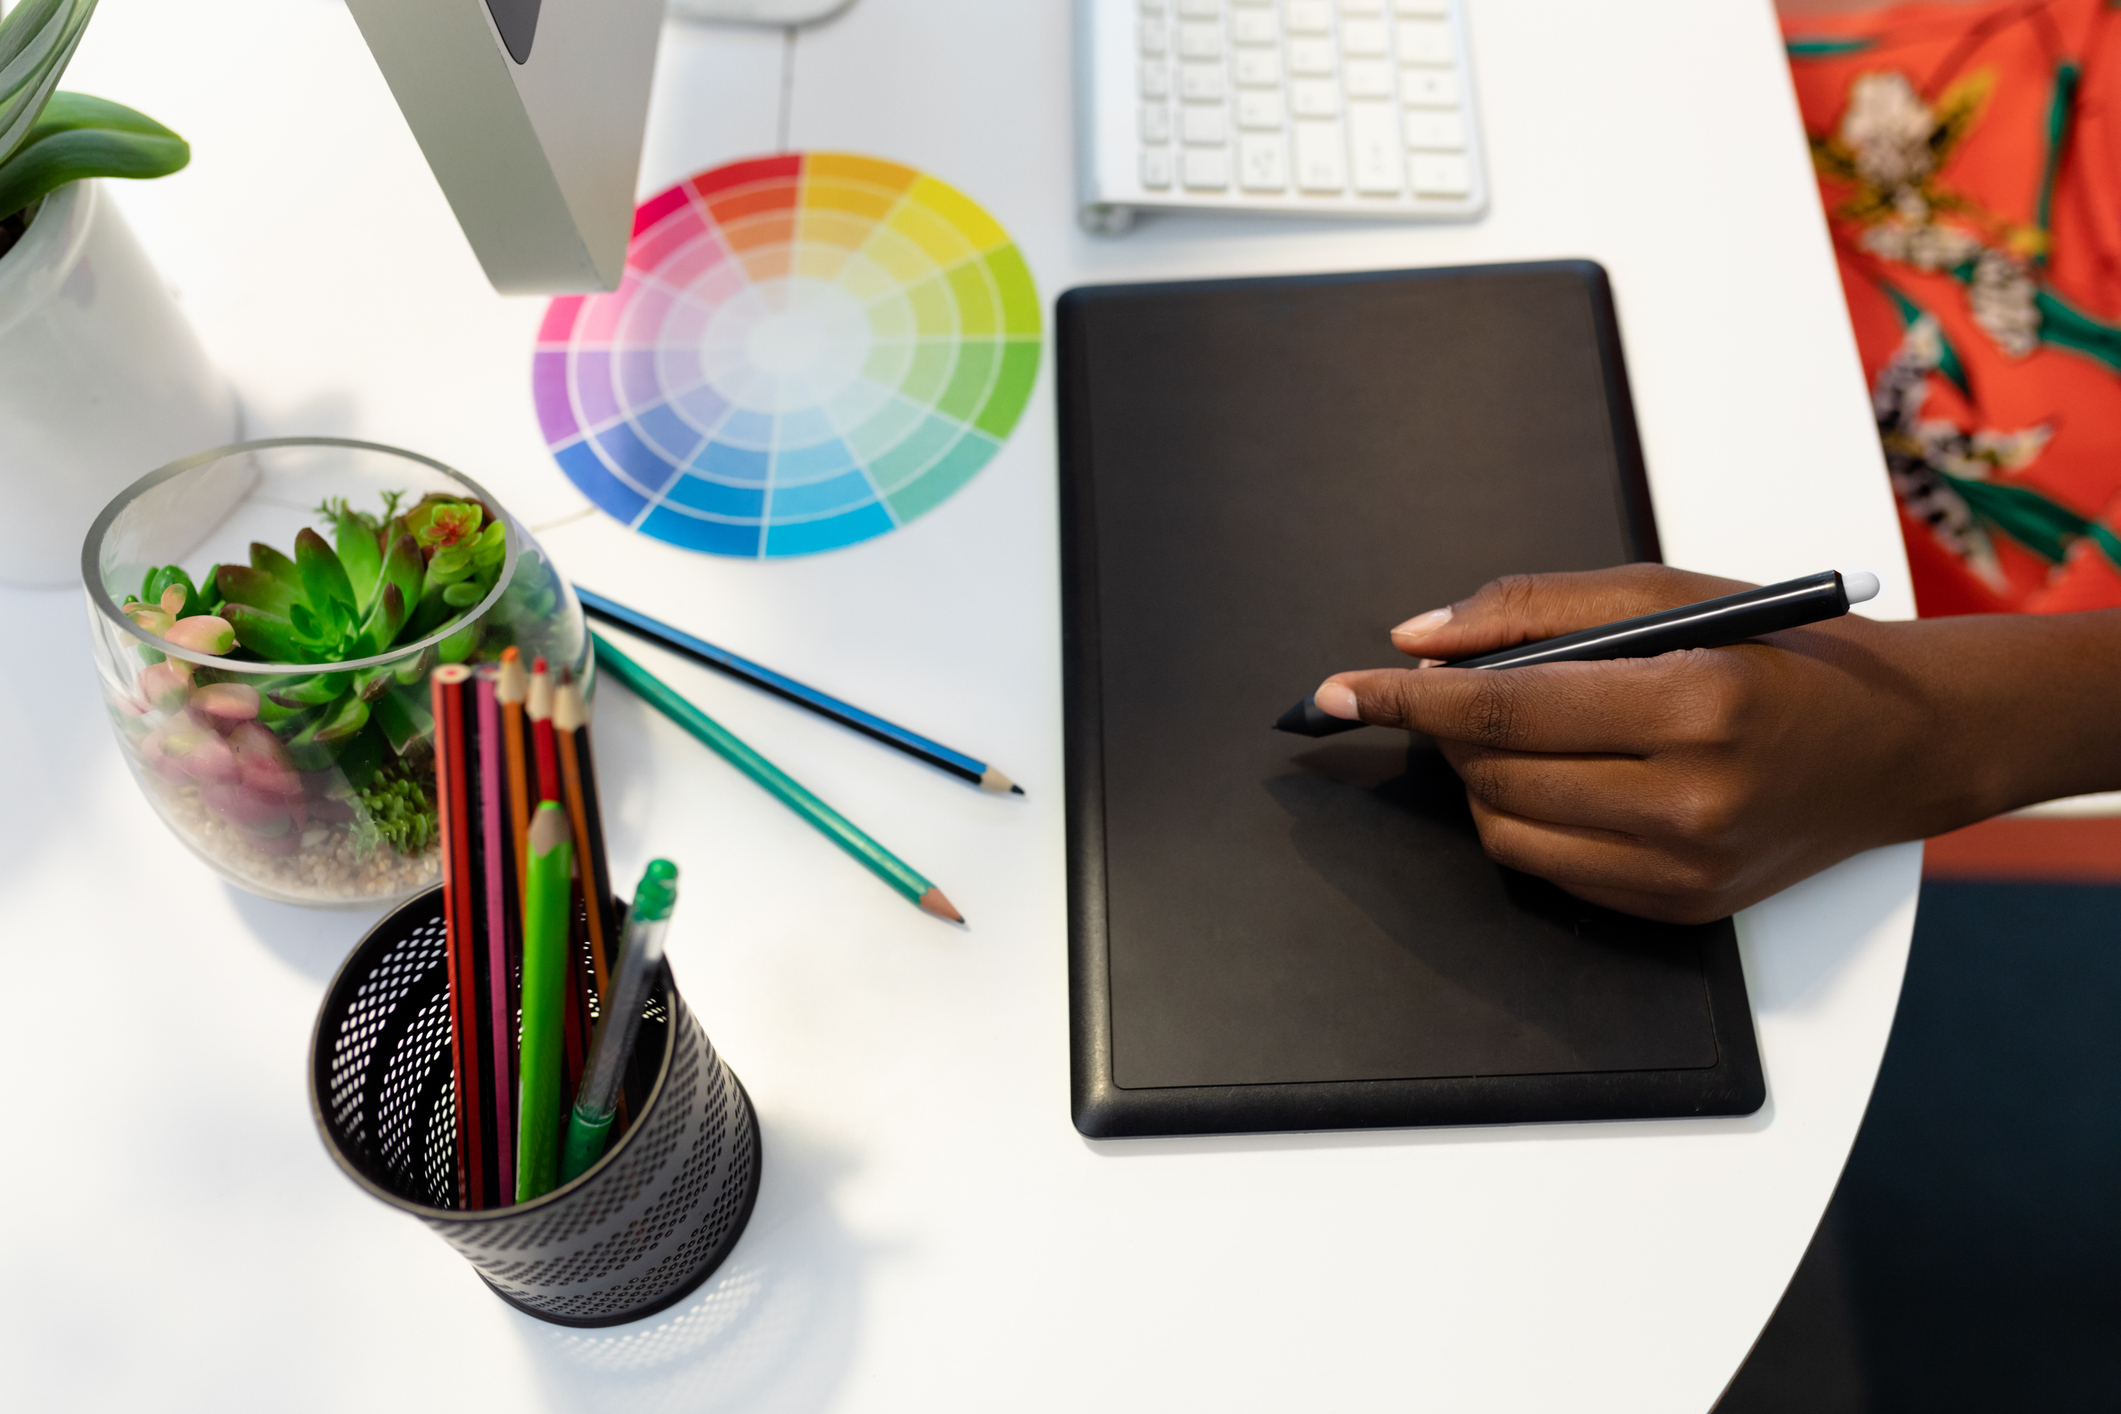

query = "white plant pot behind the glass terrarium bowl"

[{"left": 0, "top": 182, "right": 242, "bottom": 585}]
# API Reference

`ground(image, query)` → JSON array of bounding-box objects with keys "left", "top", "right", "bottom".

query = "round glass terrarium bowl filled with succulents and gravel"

[{"left": 81, "top": 437, "right": 590, "bottom": 907}]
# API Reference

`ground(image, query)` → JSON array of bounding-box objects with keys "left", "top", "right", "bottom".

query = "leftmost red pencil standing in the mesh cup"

[{"left": 431, "top": 664, "right": 486, "bottom": 1208}]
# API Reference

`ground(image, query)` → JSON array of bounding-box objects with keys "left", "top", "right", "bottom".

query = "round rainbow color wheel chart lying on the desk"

[{"left": 530, "top": 153, "right": 1044, "bottom": 558}]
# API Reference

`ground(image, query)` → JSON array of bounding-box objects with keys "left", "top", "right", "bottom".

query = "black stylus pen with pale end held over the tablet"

[{"left": 1275, "top": 570, "right": 1877, "bottom": 736}]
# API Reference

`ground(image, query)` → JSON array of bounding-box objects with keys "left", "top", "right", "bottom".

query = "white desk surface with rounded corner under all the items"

[{"left": 0, "top": 0, "right": 1920, "bottom": 1414}]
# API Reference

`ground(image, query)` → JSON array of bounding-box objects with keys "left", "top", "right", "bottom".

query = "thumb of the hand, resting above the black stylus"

[{"left": 1391, "top": 564, "right": 1752, "bottom": 661}]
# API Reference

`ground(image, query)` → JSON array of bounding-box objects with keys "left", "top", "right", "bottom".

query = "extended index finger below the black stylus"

[{"left": 1313, "top": 649, "right": 1735, "bottom": 755}]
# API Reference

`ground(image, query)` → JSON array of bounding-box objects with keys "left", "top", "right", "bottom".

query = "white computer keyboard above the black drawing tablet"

[{"left": 1075, "top": 0, "right": 1487, "bottom": 233}]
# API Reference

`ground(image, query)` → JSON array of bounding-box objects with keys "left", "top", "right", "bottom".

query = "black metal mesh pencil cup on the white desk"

[{"left": 310, "top": 888, "right": 759, "bottom": 1325}]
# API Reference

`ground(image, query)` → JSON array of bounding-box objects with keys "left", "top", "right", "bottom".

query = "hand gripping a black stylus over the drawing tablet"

[{"left": 1315, "top": 564, "right": 2009, "bottom": 922}]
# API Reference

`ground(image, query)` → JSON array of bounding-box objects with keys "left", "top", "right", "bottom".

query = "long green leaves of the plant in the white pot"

[{"left": 0, "top": 0, "right": 191, "bottom": 237}]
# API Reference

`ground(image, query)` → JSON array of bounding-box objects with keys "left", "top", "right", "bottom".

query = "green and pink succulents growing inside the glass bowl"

[{"left": 123, "top": 494, "right": 509, "bottom": 854}]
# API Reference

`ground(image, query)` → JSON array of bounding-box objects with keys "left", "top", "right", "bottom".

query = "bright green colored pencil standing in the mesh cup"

[{"left": 515, "top": 801, "right": 573, "bottom": 1202}]
